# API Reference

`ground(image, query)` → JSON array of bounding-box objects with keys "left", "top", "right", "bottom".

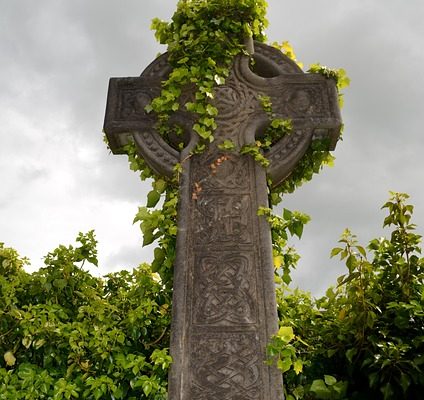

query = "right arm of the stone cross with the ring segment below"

[{"left": 238, "top": 54, "right": 342, "bottom": 186}]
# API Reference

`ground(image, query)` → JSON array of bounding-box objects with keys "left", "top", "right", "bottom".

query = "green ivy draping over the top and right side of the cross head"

[{"left": 146, "top": 0, "right": 349, "bottom": 205}]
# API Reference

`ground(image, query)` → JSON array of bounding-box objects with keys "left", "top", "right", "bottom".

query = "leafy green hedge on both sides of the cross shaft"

[{"left": 0, "top": 193, "right": 424, "bottom": 400}]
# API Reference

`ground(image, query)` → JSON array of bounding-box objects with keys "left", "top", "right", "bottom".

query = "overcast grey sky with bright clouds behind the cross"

[{"left": 0, "top": 0, "right": 424, "bottom": 295}]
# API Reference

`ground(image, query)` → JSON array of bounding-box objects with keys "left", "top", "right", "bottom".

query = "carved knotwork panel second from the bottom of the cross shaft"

[{"left": 193, "top": 252, "right": 258, "bottom": 326}]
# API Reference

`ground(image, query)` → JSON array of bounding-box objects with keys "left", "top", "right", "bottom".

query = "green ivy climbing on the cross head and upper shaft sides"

[{"left": 121, "top": 0, "right": 349, "bottom": 286}]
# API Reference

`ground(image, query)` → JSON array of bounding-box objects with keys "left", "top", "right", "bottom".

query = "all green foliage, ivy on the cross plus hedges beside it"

[{"left": 14, "top": 0, "right": 424, "bottom": 400}]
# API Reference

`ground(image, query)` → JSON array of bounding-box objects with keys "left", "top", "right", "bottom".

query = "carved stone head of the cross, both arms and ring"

[{"left": 104, "top": 42, "right": 341, "bottom": 185}]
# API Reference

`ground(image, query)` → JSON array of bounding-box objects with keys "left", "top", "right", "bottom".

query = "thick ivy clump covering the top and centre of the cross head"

[{"left": 151, "top": 0, "right": 267, "bottom": 147}]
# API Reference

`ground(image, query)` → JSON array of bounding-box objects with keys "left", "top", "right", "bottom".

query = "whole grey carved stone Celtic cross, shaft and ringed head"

[{"left": 104, "top": 43, "right": 341, "bottom": 400}]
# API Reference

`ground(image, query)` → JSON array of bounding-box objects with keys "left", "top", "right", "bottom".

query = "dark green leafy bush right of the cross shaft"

[{"left": 270, "top": 193, "right": 424, "bottom": 400}]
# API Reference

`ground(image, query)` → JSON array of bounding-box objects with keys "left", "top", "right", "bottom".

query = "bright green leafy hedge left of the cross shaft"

[{"left": 0, "top": 232, "right": 171, "bottom": 400}]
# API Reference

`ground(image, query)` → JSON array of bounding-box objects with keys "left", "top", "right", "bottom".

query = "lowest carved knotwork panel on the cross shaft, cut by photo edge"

[{"left": 191, "top": 333, "right": 263, "bottom": 400}]
